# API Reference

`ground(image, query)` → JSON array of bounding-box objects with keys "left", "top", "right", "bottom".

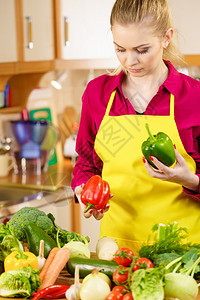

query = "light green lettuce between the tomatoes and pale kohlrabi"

[{"left": 130, "top": 268, "right": 164, "bottom": 300}]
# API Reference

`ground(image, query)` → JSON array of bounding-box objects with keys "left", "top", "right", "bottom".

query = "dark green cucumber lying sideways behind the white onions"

[{"left": 67, "top": 257, "right": 119, "bottom": 279}]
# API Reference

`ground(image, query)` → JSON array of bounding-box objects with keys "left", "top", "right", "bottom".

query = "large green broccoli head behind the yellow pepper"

[{"left": 9, "top": 207, "right": 54, "bottom": 242}]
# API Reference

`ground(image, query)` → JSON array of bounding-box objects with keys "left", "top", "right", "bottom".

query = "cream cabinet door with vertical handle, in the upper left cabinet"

[{"left": 22, "top": 0, "right": 54, "bottom": 61}]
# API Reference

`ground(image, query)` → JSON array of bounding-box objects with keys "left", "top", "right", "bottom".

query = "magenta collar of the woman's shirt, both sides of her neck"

[{"left": 112, "top": 61, "right": 181, "bottom": 95}]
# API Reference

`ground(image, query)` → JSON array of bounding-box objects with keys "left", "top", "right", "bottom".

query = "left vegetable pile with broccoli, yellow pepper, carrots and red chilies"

[{"left": 0, "top": 207, "right": 90, "bottom": 300}]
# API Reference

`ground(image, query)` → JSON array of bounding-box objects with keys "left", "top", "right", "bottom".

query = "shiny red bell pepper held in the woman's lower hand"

[{"left": 81, "top": 175, "right": 110, "bottom": 212}]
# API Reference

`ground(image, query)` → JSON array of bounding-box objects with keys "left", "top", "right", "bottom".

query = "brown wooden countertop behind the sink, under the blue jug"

[{"left": 0, "top": 159, "right": 73, "bottom": 190}]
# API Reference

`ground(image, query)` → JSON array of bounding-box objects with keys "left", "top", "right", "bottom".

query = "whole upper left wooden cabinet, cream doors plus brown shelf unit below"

[{"left": 0, "top": 0, "right": 55, "bottom": 114}]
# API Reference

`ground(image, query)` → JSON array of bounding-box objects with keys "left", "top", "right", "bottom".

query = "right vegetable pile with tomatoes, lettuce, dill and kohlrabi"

[{"left": 107, "top": 222, "right": 200, "bottom": 300}]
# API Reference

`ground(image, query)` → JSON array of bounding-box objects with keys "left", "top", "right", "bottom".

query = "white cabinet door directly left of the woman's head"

[{"left": 60, "top": 0, "right": 115, "bottom": 59}]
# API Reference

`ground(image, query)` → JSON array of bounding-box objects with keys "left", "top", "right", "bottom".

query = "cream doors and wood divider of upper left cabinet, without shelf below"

[{"left": 0, "top": 0, "right": 54, "bottom": 63}]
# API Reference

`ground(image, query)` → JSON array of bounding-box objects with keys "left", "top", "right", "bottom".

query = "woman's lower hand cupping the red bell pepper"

[{"left": 75, "top": 184, "right": 112, "bottom": 220}]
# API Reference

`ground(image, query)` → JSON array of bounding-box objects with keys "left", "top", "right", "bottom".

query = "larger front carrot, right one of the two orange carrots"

[{"left": 39, "top": 248, "right": 70, "bottom": 290}]
